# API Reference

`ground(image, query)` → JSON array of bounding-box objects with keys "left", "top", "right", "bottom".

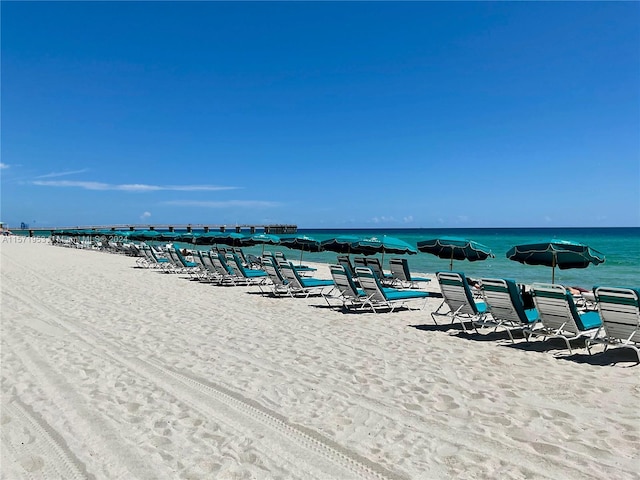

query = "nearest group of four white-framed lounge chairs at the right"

[{"left": 431, "top": 272, "right": 640, "bottom": 362}]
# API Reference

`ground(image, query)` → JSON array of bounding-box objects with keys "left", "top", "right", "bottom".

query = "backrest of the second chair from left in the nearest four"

[{"left": 480, "top": 278, "right": 532, "bottom": 325}]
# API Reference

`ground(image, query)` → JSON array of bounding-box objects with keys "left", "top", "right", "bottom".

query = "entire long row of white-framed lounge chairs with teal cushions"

[{"left": 58, "top": 240, "right": 640, "bottom": 362}]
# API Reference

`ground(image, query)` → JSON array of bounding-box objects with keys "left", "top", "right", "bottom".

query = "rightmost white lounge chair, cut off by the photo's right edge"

[{"left": 587, "top": 287, "right": 640, "bottom": 363}]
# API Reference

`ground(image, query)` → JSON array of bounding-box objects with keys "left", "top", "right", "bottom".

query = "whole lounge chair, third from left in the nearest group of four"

[{"left": 524, "top": 283, "right": 602, "bottom": 353}]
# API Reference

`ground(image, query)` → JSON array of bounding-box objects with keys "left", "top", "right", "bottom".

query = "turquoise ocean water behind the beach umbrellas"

[{"left": 232, "top": 228, "right": 640, "bottom": 288}]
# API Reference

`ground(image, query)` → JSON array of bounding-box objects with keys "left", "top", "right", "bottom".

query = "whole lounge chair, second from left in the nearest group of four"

[{"left": 473, "top": 278, "right": 538, "bottom": 342}]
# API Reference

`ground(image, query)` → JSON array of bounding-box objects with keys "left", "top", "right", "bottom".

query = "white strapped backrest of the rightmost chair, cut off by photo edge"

[{"left": 594, "top": 287, "right": 640, "bottom": 342}]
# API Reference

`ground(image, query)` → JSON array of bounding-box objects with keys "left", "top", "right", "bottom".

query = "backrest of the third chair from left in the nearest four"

[{"left": 531, "top": 283, "right": 586, "bottom": 334}]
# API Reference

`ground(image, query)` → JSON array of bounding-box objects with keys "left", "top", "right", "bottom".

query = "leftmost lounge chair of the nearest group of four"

[{"left": 431, "top": 272, "right": 487, "bottom": 332}]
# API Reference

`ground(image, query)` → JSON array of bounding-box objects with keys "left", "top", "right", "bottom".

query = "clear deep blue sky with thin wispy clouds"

[{"left": 0, "top": 2, "right": 640, "bottom": 228}]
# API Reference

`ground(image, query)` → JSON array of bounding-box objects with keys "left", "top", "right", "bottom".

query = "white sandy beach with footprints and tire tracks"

[{"left": 0, "top": 241, "right": 640, "bottom": 480}]
